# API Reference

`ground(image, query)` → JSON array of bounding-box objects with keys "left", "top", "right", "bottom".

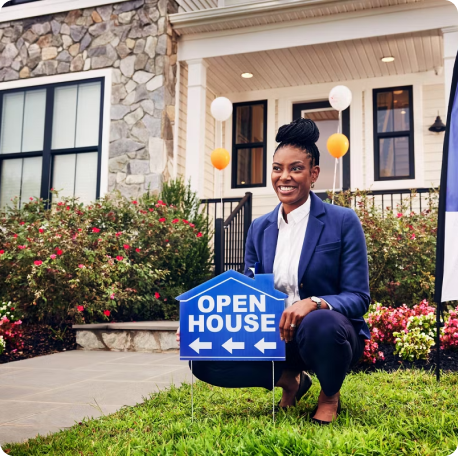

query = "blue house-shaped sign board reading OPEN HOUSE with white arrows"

[{"left": 176, "top": 270, "right": 287, "bottom": 361}]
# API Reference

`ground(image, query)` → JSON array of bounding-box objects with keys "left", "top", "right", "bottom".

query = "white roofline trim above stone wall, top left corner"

[{"left": 0, "top": 0, "right": 125, "bottom": 23}]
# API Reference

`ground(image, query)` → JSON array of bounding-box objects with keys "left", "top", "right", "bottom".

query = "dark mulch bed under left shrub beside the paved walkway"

[{"left": 0, "top": 324, "right": 76, "bottom": 364}]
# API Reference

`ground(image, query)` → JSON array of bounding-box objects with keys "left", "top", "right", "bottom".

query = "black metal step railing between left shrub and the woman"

[{"left": 201, "top": 192, "right": 253, "bottom": 275}]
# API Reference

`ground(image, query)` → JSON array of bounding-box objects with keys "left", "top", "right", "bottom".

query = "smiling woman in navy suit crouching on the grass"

[{"left": 188, "top": 118, "right": 370, "bottom": 424}]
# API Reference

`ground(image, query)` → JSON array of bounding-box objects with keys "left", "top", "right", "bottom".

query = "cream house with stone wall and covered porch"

[{"left": 0, "top": 0, "right": 458, "bottom": 218}]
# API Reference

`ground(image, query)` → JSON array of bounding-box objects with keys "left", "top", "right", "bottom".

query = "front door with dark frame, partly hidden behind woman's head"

[{"left": 293, "top": 101, "right": 350, "bottom": 199}]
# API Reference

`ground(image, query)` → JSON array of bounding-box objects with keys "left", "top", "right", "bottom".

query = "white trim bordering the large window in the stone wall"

[{"left": 0, "top": 69, "right": 112, "bottom": 197}]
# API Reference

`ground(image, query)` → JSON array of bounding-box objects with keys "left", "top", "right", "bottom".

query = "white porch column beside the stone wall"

[{"left": 186, "top": 59, "right": 208, "bottom": 197}]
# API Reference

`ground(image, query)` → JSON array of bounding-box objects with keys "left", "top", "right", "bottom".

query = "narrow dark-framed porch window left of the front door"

[{"left": 232, "top": 100, "right": 267, "bottom": 188}]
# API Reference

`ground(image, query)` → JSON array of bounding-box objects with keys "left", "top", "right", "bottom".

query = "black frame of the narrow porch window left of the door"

[{"left": 231, "top": 100, "right": 267, "bottom": 188}]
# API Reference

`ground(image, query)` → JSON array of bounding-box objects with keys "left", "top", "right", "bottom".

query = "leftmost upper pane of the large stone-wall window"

[{"left": 1, "top": 92, "right": 24, "bottom": 154}]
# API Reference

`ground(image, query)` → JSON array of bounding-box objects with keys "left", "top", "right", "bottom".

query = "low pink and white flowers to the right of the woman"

[{"left": 362, "top": 300, "right": 458, "bottom": 363}]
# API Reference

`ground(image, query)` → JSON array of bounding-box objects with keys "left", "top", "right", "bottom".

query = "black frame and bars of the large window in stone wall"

[{"left": 0, "top": 77, "right": 105, "bottom": 208}]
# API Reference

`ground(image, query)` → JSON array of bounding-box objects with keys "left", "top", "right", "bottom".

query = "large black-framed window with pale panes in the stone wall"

[{"left": 0, "top": 79, "right": 103, "bottom": 207}]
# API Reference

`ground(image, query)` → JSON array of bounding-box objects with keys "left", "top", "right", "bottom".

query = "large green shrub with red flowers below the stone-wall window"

[{"left": 0, "top": 180, "right": 210, "bottom": 326}]
